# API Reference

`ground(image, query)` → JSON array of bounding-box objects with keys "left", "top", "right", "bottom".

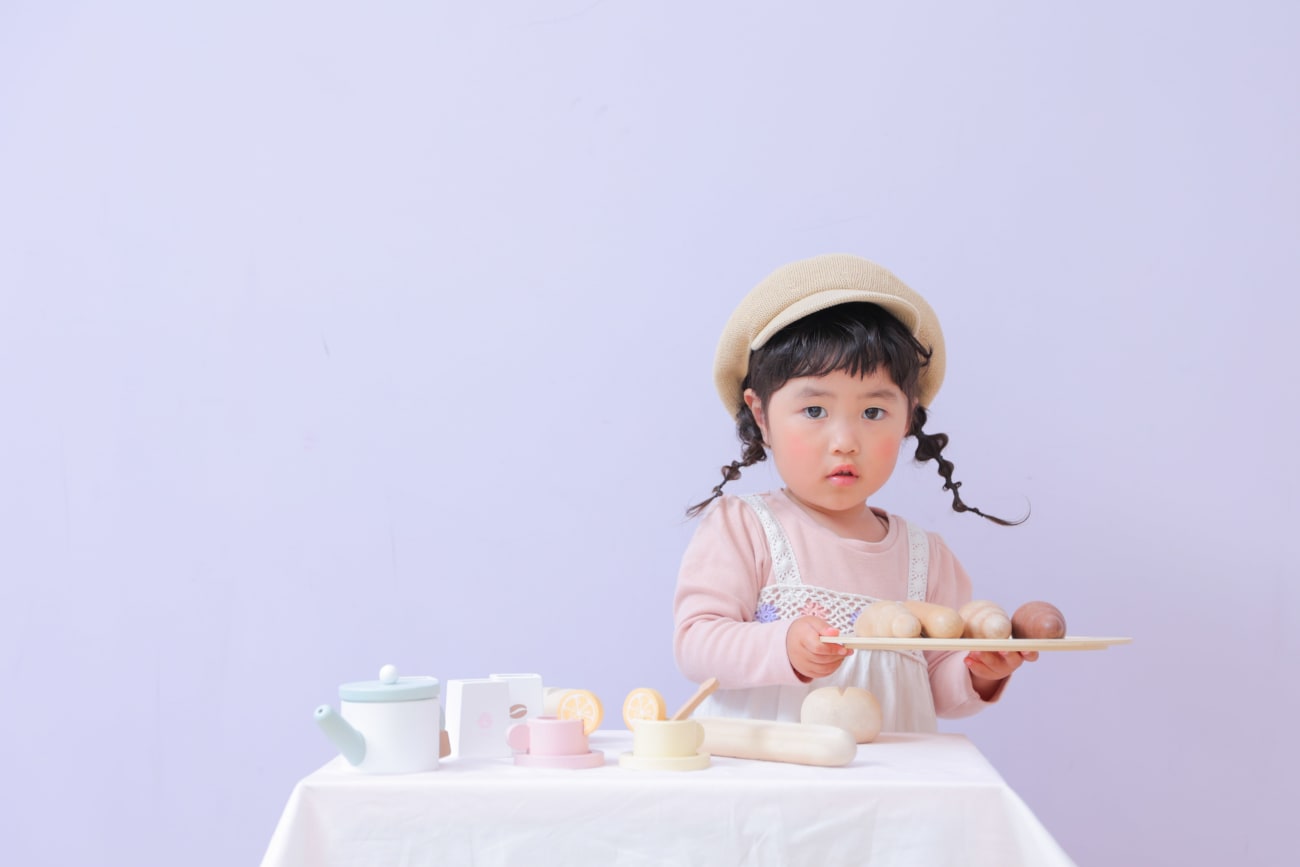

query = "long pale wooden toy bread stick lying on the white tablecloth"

[{"left": 696, "top": 716, "right": 858, "bottom": 767}]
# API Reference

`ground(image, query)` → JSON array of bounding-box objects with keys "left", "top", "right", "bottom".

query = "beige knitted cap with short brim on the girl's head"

[{"left": 714, "top": 253, "right": 944, "bottom": 419}]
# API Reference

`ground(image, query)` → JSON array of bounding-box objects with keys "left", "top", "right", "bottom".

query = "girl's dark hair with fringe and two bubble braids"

[{"left": 686, "top": 303, "right": 1024, "bottom": 526}]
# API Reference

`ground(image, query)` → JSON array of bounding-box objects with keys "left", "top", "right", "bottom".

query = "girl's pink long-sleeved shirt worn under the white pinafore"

[{"left": 673, "top": 491, "right": 1006, "bottom": 718}]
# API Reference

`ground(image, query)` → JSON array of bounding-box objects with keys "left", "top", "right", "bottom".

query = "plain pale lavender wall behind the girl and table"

[{"left": 0, "top": 0, "right": 1300, "bottom": 866}]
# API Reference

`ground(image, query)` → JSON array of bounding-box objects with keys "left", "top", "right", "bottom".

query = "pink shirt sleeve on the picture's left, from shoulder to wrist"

[{"left": 673, "top": 497, "right": 800, "bottom": 689}]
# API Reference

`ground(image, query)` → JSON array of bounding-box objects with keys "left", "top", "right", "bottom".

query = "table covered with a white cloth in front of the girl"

[{"left": 263, "top": 731, "right": 1073, "bottom": 867}]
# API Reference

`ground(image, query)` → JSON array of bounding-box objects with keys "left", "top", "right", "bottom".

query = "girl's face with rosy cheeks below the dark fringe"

[{"left": 745, "top": 368, "right": 911, "bottom": 520}]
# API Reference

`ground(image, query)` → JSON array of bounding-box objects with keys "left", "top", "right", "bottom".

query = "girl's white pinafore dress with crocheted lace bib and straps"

[{"left": 696, "top": 494, "right": 939, "bottom": 732}]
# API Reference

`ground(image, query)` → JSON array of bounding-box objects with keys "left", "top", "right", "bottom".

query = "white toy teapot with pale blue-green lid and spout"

[{"left": 316, "top": 666, "right": 442, "bottom": 773}]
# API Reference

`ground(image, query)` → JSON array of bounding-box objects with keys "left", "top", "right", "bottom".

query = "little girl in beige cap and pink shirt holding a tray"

[{"left": 673, "top": 255, "right": 1036, "bottom": 732}]
